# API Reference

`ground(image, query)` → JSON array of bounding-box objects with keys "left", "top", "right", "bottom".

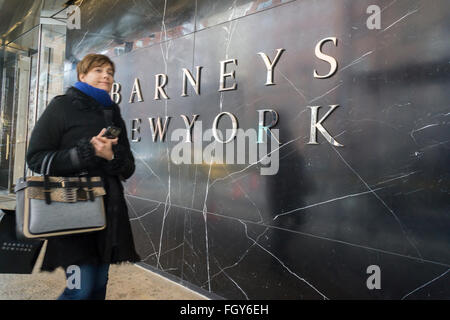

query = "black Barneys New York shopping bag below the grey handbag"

[{"left": 0, "top": 211, "right": 44, "bottom": 274}]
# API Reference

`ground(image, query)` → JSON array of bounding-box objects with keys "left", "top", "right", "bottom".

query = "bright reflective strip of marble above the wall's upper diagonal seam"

[{"left": 64, "top": 0, "right": 292, "bottom": 61}]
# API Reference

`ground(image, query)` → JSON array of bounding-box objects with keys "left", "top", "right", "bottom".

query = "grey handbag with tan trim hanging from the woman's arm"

[{"left": 14, "top": 152, "right": 106, "bottom": 239}]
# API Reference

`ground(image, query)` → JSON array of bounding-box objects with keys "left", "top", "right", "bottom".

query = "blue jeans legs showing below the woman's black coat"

[{"left": 58, "top": 264, "right": 109, "bottom": 300}]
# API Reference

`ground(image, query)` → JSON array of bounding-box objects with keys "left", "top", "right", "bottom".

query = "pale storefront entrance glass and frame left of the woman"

[{"left": 0, "top": 25, "right": 66, "bottom": 193}]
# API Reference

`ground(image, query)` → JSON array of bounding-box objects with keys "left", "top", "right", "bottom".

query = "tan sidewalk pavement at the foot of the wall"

[{"left": 0, "top": 241, "right": 206, "bottom": 300}]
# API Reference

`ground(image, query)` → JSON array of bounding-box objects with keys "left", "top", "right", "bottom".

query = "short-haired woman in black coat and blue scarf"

[{"left": 26, "top": 54, "right": 140, "bottom": 300}]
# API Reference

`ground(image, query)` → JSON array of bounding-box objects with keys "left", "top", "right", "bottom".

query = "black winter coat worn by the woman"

[{"left": 26, "top": 87, "right": 140, "bottom": 271}]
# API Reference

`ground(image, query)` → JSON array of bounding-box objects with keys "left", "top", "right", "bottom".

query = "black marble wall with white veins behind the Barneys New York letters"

[{"left": 66, "top": 0, "right": 450, "bottom": 299}]
